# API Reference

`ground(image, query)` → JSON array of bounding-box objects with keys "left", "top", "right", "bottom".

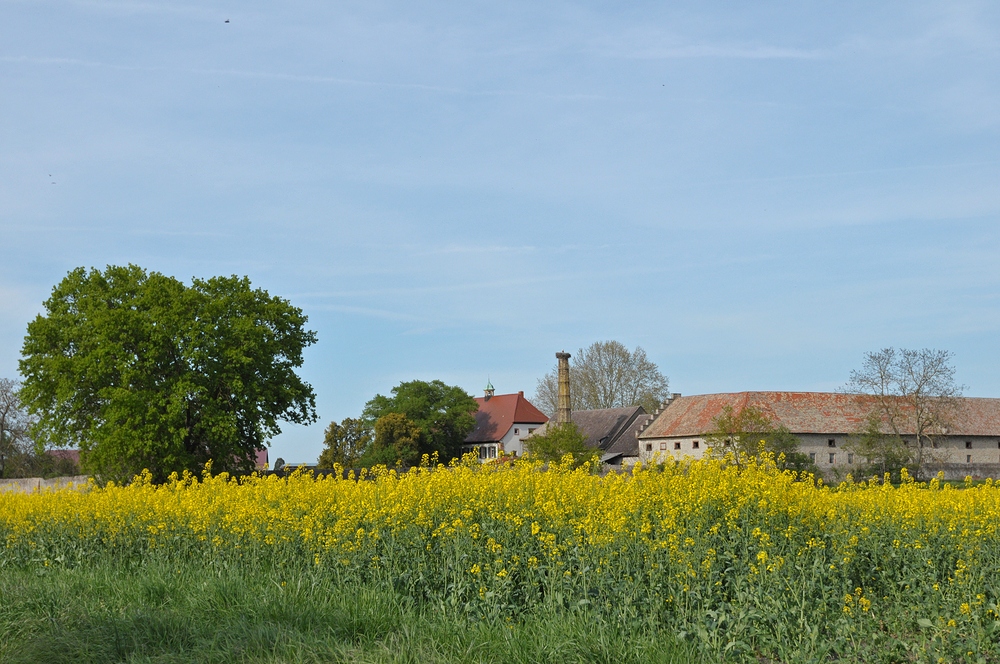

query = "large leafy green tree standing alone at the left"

[{"left": 20, "top": 265, "right": 316, "bottom": 480}]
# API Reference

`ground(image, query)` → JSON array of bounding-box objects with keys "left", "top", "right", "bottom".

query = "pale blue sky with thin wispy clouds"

[{"left": 0, "top": 0, "right": 1000, "bottom": 461}]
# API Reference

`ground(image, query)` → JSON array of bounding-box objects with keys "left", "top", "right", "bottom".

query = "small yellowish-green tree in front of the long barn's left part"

[{"left": 705, "top": 404, "right": 817, "bottom": 473}]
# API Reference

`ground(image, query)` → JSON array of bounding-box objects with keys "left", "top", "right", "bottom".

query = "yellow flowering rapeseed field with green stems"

[{"left": 0, "top": 460, "right": 1000, "bottom": 662}]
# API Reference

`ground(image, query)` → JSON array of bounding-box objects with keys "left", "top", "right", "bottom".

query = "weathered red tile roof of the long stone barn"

[{"left": 639, "top": 392, "right": 1000, "bottom": 438}]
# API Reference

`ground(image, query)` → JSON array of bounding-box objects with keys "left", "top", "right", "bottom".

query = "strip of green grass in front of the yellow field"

[{"left": 0, "top": 563, "right": 699, "bottom": 664}]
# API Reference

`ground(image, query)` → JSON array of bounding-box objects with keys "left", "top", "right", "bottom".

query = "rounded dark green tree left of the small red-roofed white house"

[{"left": 362, "top": 380, "right": 479, "bottom": 462}]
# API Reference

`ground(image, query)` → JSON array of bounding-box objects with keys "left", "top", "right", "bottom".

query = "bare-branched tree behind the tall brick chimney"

[{"left": 532, "top": 341, "right": 669, "bottom": 417}]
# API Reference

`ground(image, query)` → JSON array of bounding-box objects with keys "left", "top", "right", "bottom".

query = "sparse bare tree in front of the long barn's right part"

[{"left": 845, "top": 348, "right": 963, "bottom": 475}]
